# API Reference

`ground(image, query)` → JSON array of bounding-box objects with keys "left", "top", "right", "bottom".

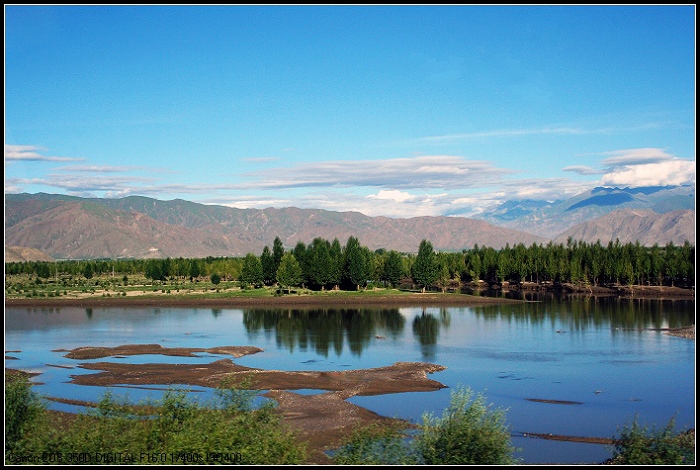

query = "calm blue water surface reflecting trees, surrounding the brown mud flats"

[{"left": 5, "top": 298, "right": 695, "bottom": 463}]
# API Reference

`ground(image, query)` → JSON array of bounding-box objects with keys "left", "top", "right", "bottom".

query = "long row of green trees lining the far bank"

[{"left": 5, "top": 236, "right": 695, "bottom": 290}]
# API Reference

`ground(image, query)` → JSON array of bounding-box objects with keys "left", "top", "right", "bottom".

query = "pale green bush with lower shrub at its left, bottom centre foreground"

[{"left": 333, "top": 388, "right": 516, "bottom": 465}]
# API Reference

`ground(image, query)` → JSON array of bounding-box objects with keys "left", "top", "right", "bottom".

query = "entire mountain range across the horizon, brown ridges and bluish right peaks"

[{"left": 5, "top": 186, "right": 695, "bottom": 261}]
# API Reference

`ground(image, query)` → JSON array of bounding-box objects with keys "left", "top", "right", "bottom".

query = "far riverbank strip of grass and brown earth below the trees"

[{"left": 5, "top": 283, "right": 695, "bottom": 308}]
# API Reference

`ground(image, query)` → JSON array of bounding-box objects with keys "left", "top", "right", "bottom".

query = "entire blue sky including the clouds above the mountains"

[{"left": 5, "top": 5, "right": 695, "bottom": 217}]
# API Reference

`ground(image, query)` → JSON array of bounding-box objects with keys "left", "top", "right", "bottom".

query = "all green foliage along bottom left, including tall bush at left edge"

[{"left": 5, "top": 377, "right": 306, "bottom": 465}]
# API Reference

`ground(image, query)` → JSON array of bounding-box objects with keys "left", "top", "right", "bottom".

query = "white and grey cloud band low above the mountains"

[{"left": 5, "top": 145, "right": 695, "bottom": 218}]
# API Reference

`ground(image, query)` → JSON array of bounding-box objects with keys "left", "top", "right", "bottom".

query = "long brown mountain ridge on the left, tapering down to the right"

[{"left": 5, "top": 194, "right": 545, "bottom": 259}]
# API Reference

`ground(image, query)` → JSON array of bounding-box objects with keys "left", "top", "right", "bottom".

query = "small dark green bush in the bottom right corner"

[{"left": 611, "top": 419, "right": 695, "bottom": 465}]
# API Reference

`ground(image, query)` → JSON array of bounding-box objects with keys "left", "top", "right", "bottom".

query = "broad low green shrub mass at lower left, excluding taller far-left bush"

[{"left": 17, "top": 384, "right": 306, "bottom": 465}]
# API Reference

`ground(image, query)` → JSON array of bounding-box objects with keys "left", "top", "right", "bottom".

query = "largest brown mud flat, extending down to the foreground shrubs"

[{"left": 65, "top": 356, "right": 446, "bottom": 464}]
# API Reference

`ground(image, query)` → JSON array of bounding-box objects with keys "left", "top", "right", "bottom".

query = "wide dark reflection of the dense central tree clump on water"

[{"left": 243, "top": 308, "right": 406, "bottom": 357}]
